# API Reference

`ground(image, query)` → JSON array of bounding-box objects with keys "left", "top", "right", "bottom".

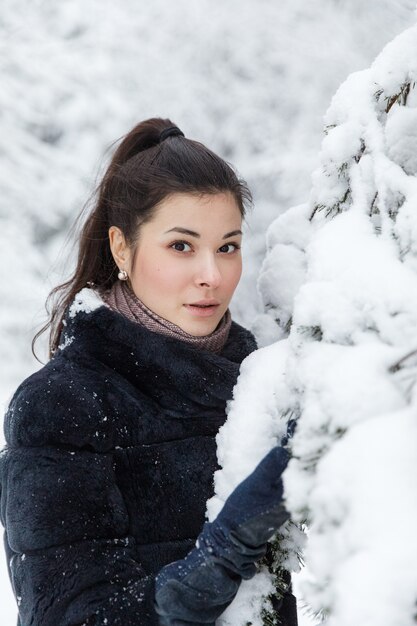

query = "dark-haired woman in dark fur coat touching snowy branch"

[{"left": 1, "top": 118, "right": 296, "bottom": 626}]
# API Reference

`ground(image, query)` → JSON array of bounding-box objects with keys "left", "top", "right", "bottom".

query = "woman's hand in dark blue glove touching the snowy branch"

[{"left": 155, "top": 446, "right": 289, "bottom": 626}]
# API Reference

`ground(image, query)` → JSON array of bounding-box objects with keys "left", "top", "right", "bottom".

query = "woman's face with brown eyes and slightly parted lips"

[{"left": 109, "top": 193, "right": 242, "bottom": 336}]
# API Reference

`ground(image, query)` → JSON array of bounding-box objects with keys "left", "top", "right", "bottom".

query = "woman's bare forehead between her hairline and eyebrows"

[{"left": 149, "top": 192, "right": 242, "bottom": 232}]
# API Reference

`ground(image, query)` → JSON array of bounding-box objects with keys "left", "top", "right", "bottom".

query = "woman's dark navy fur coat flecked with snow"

[{"left": 0, "top": 294, "right": 256, "bottom": 626}]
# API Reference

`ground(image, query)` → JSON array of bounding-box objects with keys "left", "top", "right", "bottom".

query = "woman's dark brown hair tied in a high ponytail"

[{"left": 32, "top": 117, "right": 252, "bottom": 355}]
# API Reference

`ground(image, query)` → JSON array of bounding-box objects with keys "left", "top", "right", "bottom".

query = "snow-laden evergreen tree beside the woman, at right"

[{"left": 209, "top": 19, "right": 417, "bottom": 626}]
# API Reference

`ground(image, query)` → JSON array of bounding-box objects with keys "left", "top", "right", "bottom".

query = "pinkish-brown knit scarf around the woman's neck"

[{"left": 100, "top": 280, "right": 232, "bottom": 352}]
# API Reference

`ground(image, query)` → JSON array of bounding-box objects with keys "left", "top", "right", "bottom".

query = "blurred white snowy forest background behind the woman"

[{"left": 0, "top": 0, "right": 416, "bottom": 626}]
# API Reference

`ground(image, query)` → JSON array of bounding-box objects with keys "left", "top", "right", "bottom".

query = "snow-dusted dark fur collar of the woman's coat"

[{"left": 58, "top": 289, "right": 256, "bottom": 418}]
